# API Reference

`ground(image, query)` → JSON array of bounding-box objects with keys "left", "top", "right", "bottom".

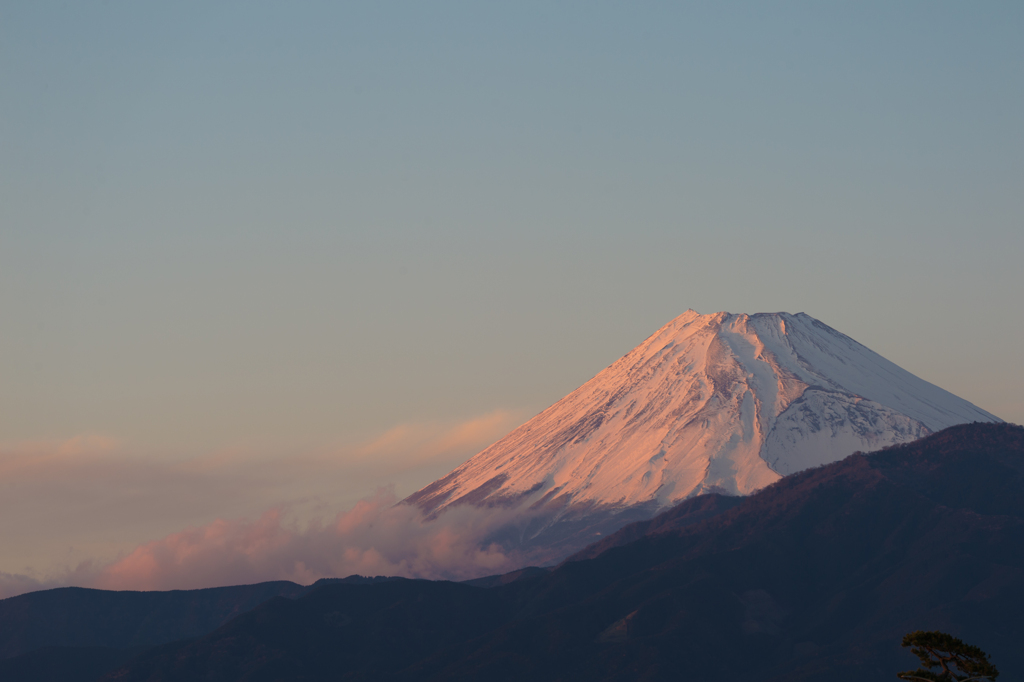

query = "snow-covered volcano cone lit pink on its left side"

[{"left": 404, "top": 310, "right": 1001, "bottom": 544}]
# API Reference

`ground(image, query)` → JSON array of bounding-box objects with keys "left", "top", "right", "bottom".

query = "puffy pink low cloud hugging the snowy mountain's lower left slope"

[{"left": 92, "top": 488, "right": 516, "bottom": 590}]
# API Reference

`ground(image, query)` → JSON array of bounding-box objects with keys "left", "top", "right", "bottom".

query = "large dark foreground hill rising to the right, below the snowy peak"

[{"left": 0, "top": 424, "right": 1024, "bottom": 682}]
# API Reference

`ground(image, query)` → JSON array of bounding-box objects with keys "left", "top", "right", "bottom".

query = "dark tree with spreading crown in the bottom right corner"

[{"left": 896, "top": 630, "right": 999, "bottom": 682}]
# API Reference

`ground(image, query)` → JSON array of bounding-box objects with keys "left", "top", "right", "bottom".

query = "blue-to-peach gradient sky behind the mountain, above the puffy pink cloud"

[{"left": 0, "top": 1, "right": 1024, "bottom": 585}]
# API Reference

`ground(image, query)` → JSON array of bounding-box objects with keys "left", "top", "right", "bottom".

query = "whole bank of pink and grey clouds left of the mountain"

[{"left": 0, "top": 411, "right": 524, "bottom": 598}]
